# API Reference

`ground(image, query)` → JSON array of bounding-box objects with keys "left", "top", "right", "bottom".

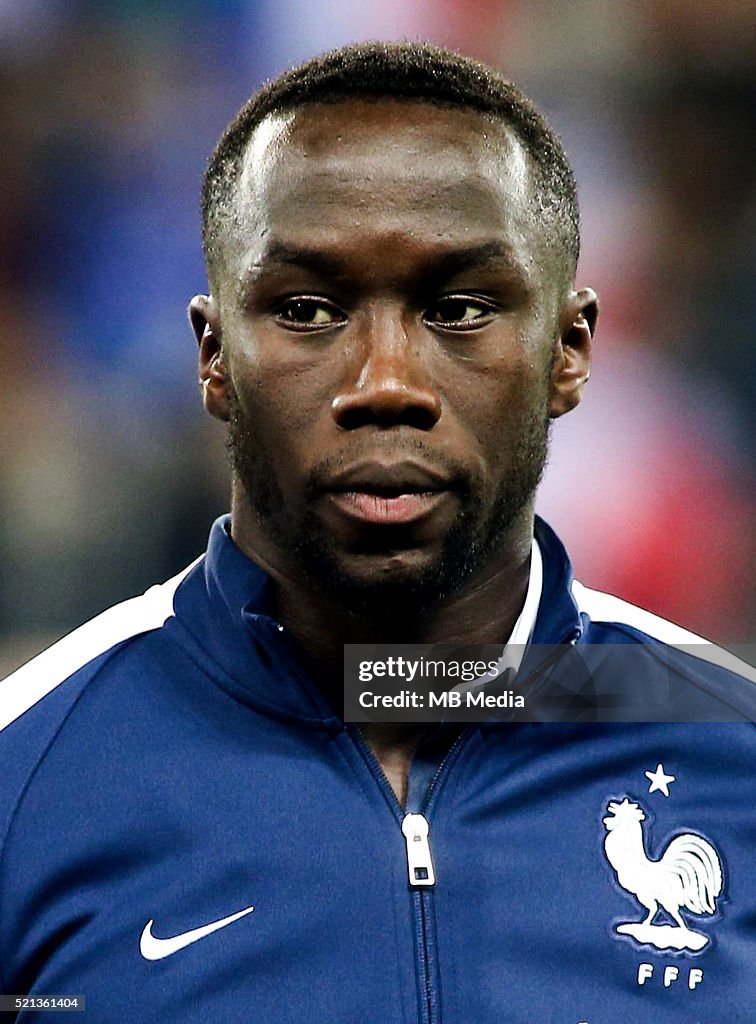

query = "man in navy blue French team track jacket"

[{"left": 0, "top": 44, "right": 756, "bottom": 1024}]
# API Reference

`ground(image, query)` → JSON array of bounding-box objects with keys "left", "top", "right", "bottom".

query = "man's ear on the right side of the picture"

[{"left": 549, "top": 288, "right": 598, "bottom": 420}]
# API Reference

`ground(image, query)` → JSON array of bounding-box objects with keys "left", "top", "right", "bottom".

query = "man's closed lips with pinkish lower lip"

[{"left": 323, "top": 462, "right": 452, "bottom": 525}]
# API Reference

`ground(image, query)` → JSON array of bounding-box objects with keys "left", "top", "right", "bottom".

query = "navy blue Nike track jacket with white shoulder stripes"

[{"left": 0, "top": 520, "right": 756, "bottom": 1024}]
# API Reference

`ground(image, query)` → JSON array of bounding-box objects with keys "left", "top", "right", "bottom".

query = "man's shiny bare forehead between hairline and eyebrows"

[{"left": 225, "top": 99, "right": 539, "bottom": 290}]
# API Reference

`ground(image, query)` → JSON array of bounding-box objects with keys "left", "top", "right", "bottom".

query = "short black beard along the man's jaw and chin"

[{"left": 227, "top": 369, "right": 551, "bottom": 623}]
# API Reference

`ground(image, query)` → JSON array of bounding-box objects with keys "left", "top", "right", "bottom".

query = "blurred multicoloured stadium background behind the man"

[{"left": 0, "top": 0, "right": 756, "bottom": 676}]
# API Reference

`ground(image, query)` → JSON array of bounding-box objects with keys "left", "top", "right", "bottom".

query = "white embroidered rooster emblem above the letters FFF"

[{"left": 603, "top": 799, "right": 722, "bottom": 952}]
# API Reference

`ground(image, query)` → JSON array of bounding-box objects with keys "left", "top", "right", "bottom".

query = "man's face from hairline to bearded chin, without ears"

[{"left": 197, "top": 101, "right": 581, "bottom": 601}]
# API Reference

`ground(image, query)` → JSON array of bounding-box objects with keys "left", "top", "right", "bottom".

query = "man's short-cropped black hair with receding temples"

[{"left": 202, "top": 42, "right": 580, "bottom": 282}]
